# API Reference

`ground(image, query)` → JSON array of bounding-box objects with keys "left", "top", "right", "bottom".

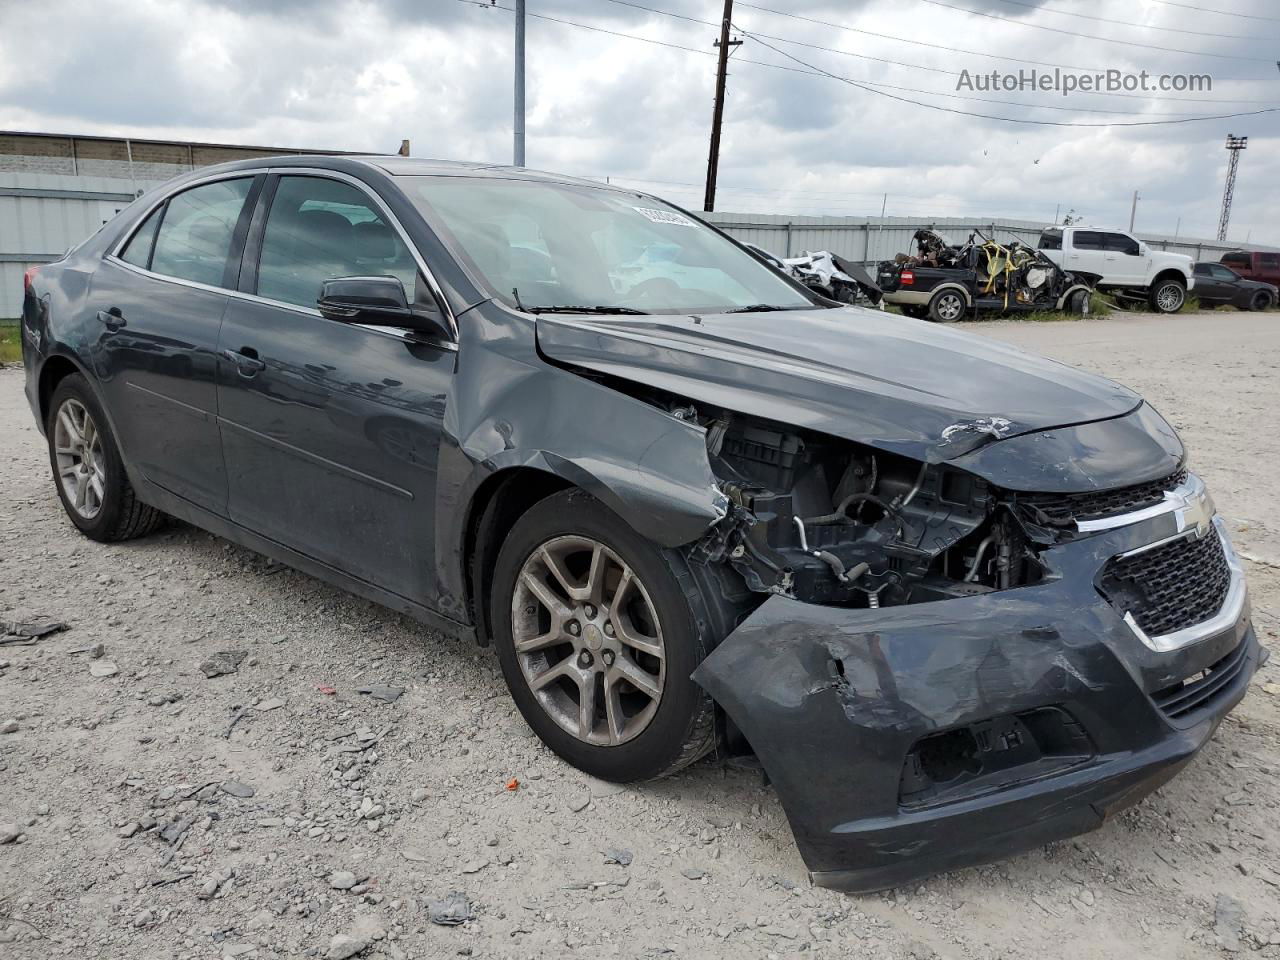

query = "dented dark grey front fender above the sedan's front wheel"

[{"left": 436, "top": 307, "right": 728, "bottom": 616}]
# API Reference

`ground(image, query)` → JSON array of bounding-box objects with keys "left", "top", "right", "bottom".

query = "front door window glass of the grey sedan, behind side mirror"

[{"left": 257, "top": 177, "right": 419, "bottom": 307}]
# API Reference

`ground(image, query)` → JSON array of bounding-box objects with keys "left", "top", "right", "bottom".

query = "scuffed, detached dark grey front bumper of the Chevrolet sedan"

[{"left": 694, "top": 511, "right": 1261, "bottom": 891}]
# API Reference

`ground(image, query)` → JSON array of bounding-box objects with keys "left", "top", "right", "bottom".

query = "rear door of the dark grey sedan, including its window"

[{"left": 91, "top": 173, "right": 265, "bottom": 513}]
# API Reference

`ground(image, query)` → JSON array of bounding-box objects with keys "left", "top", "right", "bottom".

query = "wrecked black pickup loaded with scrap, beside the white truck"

[{"left": 876, "top": 229, "right": 1097, "bottom": 324}]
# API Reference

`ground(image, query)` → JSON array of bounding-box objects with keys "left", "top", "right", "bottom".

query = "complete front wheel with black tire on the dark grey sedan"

[{"left": 489, "top": 490, "right": 735, "bottom": 783}]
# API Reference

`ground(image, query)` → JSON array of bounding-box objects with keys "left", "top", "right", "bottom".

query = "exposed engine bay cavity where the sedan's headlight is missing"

[{"left": 686, "top": 410, "right": 1044, "bottom": 608}]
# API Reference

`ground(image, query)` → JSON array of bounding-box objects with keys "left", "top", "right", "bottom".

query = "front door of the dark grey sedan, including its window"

[{"left": 218, "top": 175, "right": 457, "bottom": 605}]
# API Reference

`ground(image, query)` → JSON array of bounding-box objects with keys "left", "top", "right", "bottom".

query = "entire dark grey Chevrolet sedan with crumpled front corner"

[{"left": 22, "top": 156, "right": 1260, "bottom": 890}]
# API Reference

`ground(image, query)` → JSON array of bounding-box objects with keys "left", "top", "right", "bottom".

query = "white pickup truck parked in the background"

[{"left": 1039, "top": 227, "right": 1196, "bottom": 314}]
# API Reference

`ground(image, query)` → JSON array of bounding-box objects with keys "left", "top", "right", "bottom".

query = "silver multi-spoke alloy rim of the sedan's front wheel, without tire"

[{"left": 511, "top": 536, "right": 667, "bottom": 746}]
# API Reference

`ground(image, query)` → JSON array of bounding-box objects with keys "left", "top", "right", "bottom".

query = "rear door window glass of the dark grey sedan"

[{"left": 151, "top": 177, "right": 253, "bottom": 287}]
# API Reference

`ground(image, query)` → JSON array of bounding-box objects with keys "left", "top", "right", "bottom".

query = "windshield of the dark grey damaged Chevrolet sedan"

[{"left": 397, "top": 177, "right": 814, "bottom": 314}]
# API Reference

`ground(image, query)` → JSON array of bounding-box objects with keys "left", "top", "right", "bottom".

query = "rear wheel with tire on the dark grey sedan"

[{"left": 45, "top": 374, "right": 164, "bottom": 543}]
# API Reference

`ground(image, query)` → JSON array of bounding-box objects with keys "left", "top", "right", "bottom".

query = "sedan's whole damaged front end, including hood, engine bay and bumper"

[{"left": 539, "top": 310, "right": 1261, "bottom": 890}]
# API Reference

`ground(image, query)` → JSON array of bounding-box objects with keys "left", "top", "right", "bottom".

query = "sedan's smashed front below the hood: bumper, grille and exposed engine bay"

[{"left": 694, "top": 415, "right": 1261, "bottom": 891}]
